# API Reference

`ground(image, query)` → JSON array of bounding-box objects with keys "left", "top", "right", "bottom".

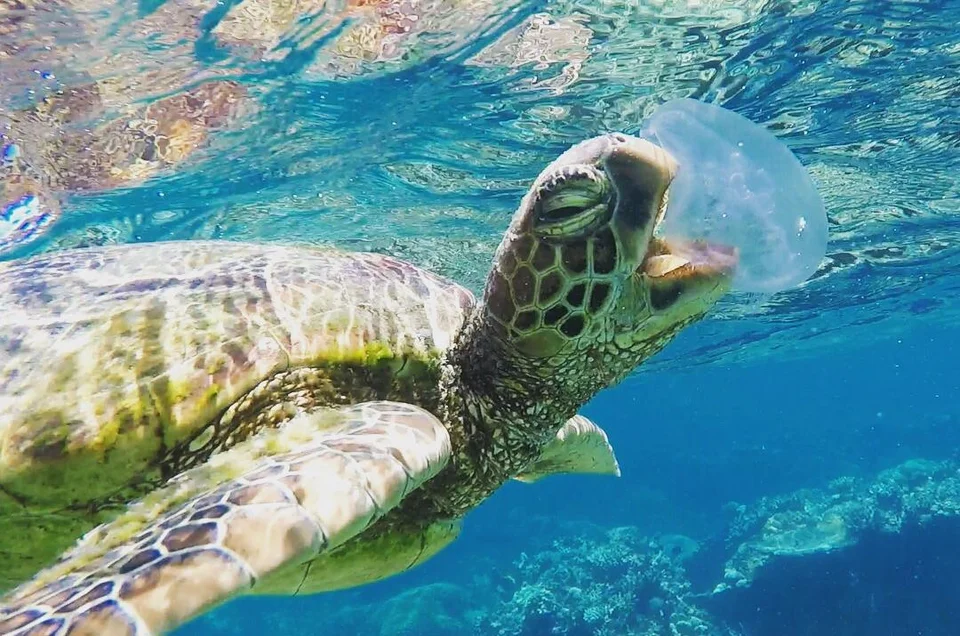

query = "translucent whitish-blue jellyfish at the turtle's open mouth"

[{"left": 641, "top": 99, "right": 827, "bottom": 293}]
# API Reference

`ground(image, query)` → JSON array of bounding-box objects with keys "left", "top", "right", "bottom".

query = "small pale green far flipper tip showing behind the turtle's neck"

[{"left": 515, "top": 415, "right": 620, "bottom": 484}]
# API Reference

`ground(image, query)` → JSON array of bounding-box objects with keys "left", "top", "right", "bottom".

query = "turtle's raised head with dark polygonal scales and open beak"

[{"left": 464, "top": 134, "right": 736, "bottom": 410}]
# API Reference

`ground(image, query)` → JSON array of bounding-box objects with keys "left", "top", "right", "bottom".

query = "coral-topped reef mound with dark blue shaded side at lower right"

[{"left": 688, "top": 460, "right": 960, "bottom": 636}]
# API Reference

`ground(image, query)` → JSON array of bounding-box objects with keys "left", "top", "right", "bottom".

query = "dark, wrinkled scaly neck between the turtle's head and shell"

[{"left": 425, "top": 307, "right": 595, "bottom": 517}]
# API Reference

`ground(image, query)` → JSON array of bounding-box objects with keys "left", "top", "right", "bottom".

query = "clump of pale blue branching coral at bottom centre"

[{"left": 477, "top": 528, "right": 718, "bottom": 636}]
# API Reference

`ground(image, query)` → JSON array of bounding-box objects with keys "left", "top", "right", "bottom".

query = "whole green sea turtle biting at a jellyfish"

[{"left": 0, "top": 133, "right": 736, "bottom": 636}]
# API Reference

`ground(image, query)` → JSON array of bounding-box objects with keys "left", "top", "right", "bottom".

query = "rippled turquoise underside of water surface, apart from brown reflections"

[{"left": 0, "top": 0, "right": 960, "bottom": 369}]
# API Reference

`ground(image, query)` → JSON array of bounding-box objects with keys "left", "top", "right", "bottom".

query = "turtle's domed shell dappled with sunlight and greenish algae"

[{"left": 0, "top": 241, "right": 474, "bottom": 515}]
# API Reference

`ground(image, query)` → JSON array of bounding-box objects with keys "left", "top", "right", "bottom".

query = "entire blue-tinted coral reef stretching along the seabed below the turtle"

[{"left": 184, "top": 460, "right": 960, "bottom": 636}]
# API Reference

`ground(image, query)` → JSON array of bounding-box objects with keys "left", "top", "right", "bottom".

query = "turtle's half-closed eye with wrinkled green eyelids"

[{"left": 535, "top": 166, "right": 610, "bottom": 236}]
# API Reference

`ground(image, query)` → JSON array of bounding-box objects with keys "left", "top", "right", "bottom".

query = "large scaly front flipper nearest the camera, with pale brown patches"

[{"left": 0, "top": 402, "right": 450, "bottom": 636}]
